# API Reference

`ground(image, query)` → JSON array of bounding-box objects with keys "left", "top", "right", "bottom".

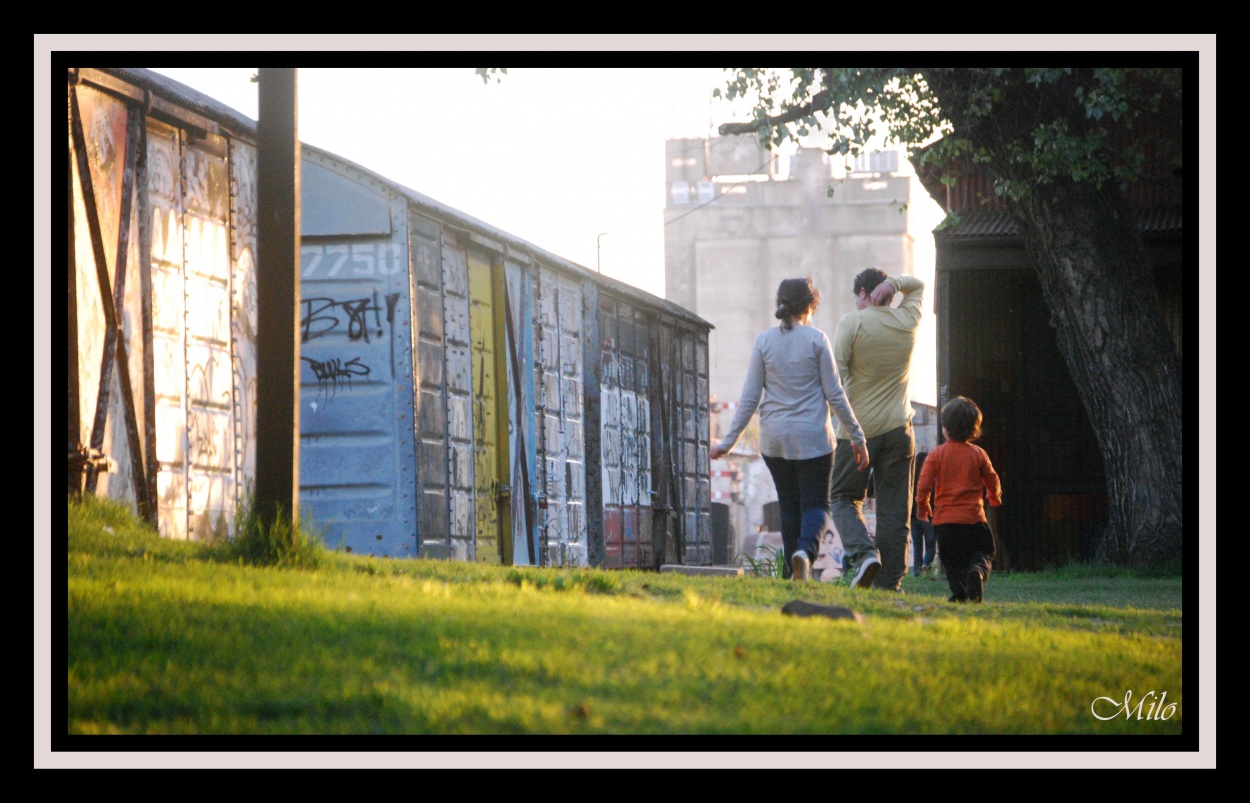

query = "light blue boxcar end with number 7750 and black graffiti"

[{"left": 299, "top": 154, "right": 419, "bottom": 558}]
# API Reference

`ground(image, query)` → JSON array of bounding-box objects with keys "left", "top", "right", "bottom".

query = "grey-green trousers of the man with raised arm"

[{"left": 830, "top": 422, "right": 916, "bottom": 590}]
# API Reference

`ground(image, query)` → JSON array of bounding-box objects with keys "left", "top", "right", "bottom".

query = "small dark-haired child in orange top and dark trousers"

[{"left": 916, "top": 396, "right": 1003, "bottom": 603}]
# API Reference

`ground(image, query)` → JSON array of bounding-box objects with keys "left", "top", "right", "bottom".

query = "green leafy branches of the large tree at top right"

[{"left": 715, "top": 68, "right": 1181, "bottom": 198}]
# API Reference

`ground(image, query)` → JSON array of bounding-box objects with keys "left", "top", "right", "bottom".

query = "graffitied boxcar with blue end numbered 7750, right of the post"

[{"left": 300, "top": 146, "right": 711, "bottom": 568}]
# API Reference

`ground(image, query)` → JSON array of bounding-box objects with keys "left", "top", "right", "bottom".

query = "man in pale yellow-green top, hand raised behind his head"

[{"left": 831, "top": 268, "right": 925, "bottom": 592}]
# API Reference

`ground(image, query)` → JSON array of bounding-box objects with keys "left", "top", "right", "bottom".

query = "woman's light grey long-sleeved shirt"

[{"left": 720, "top": 324, "right": 864, "bottom": 460}]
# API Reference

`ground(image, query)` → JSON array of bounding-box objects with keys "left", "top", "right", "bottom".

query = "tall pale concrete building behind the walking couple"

[{"left": 664, "top": 135, "right": 943, "bottom": 565}]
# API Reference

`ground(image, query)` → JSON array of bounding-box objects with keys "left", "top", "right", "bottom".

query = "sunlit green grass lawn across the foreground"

[{"left": 65, "top": 502, "right": 1184, "bottom": 735}]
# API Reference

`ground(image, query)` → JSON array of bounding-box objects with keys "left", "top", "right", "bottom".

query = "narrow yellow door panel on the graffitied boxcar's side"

[{"left": 469, "top": 254, "right": 511, "bottom": 563}]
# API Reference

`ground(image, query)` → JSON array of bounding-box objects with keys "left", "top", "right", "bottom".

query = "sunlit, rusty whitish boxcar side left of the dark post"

[{"left": 69, "top": 70, "right": 255, "bottom": 539}]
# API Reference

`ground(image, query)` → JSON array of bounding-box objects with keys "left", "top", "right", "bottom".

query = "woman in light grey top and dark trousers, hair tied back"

[{"left": 710, "top": 278, "right": 869, "bottom": 580}]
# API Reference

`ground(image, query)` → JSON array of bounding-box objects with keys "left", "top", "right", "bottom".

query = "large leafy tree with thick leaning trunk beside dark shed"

[{"left": 714, "top": 66, "right": 1183, "bottom": 564}]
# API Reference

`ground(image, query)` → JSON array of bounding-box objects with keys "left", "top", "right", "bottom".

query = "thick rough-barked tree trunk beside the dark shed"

[{"left": 1010, "top": 181, "right": 1184, "bottom": 567}]
